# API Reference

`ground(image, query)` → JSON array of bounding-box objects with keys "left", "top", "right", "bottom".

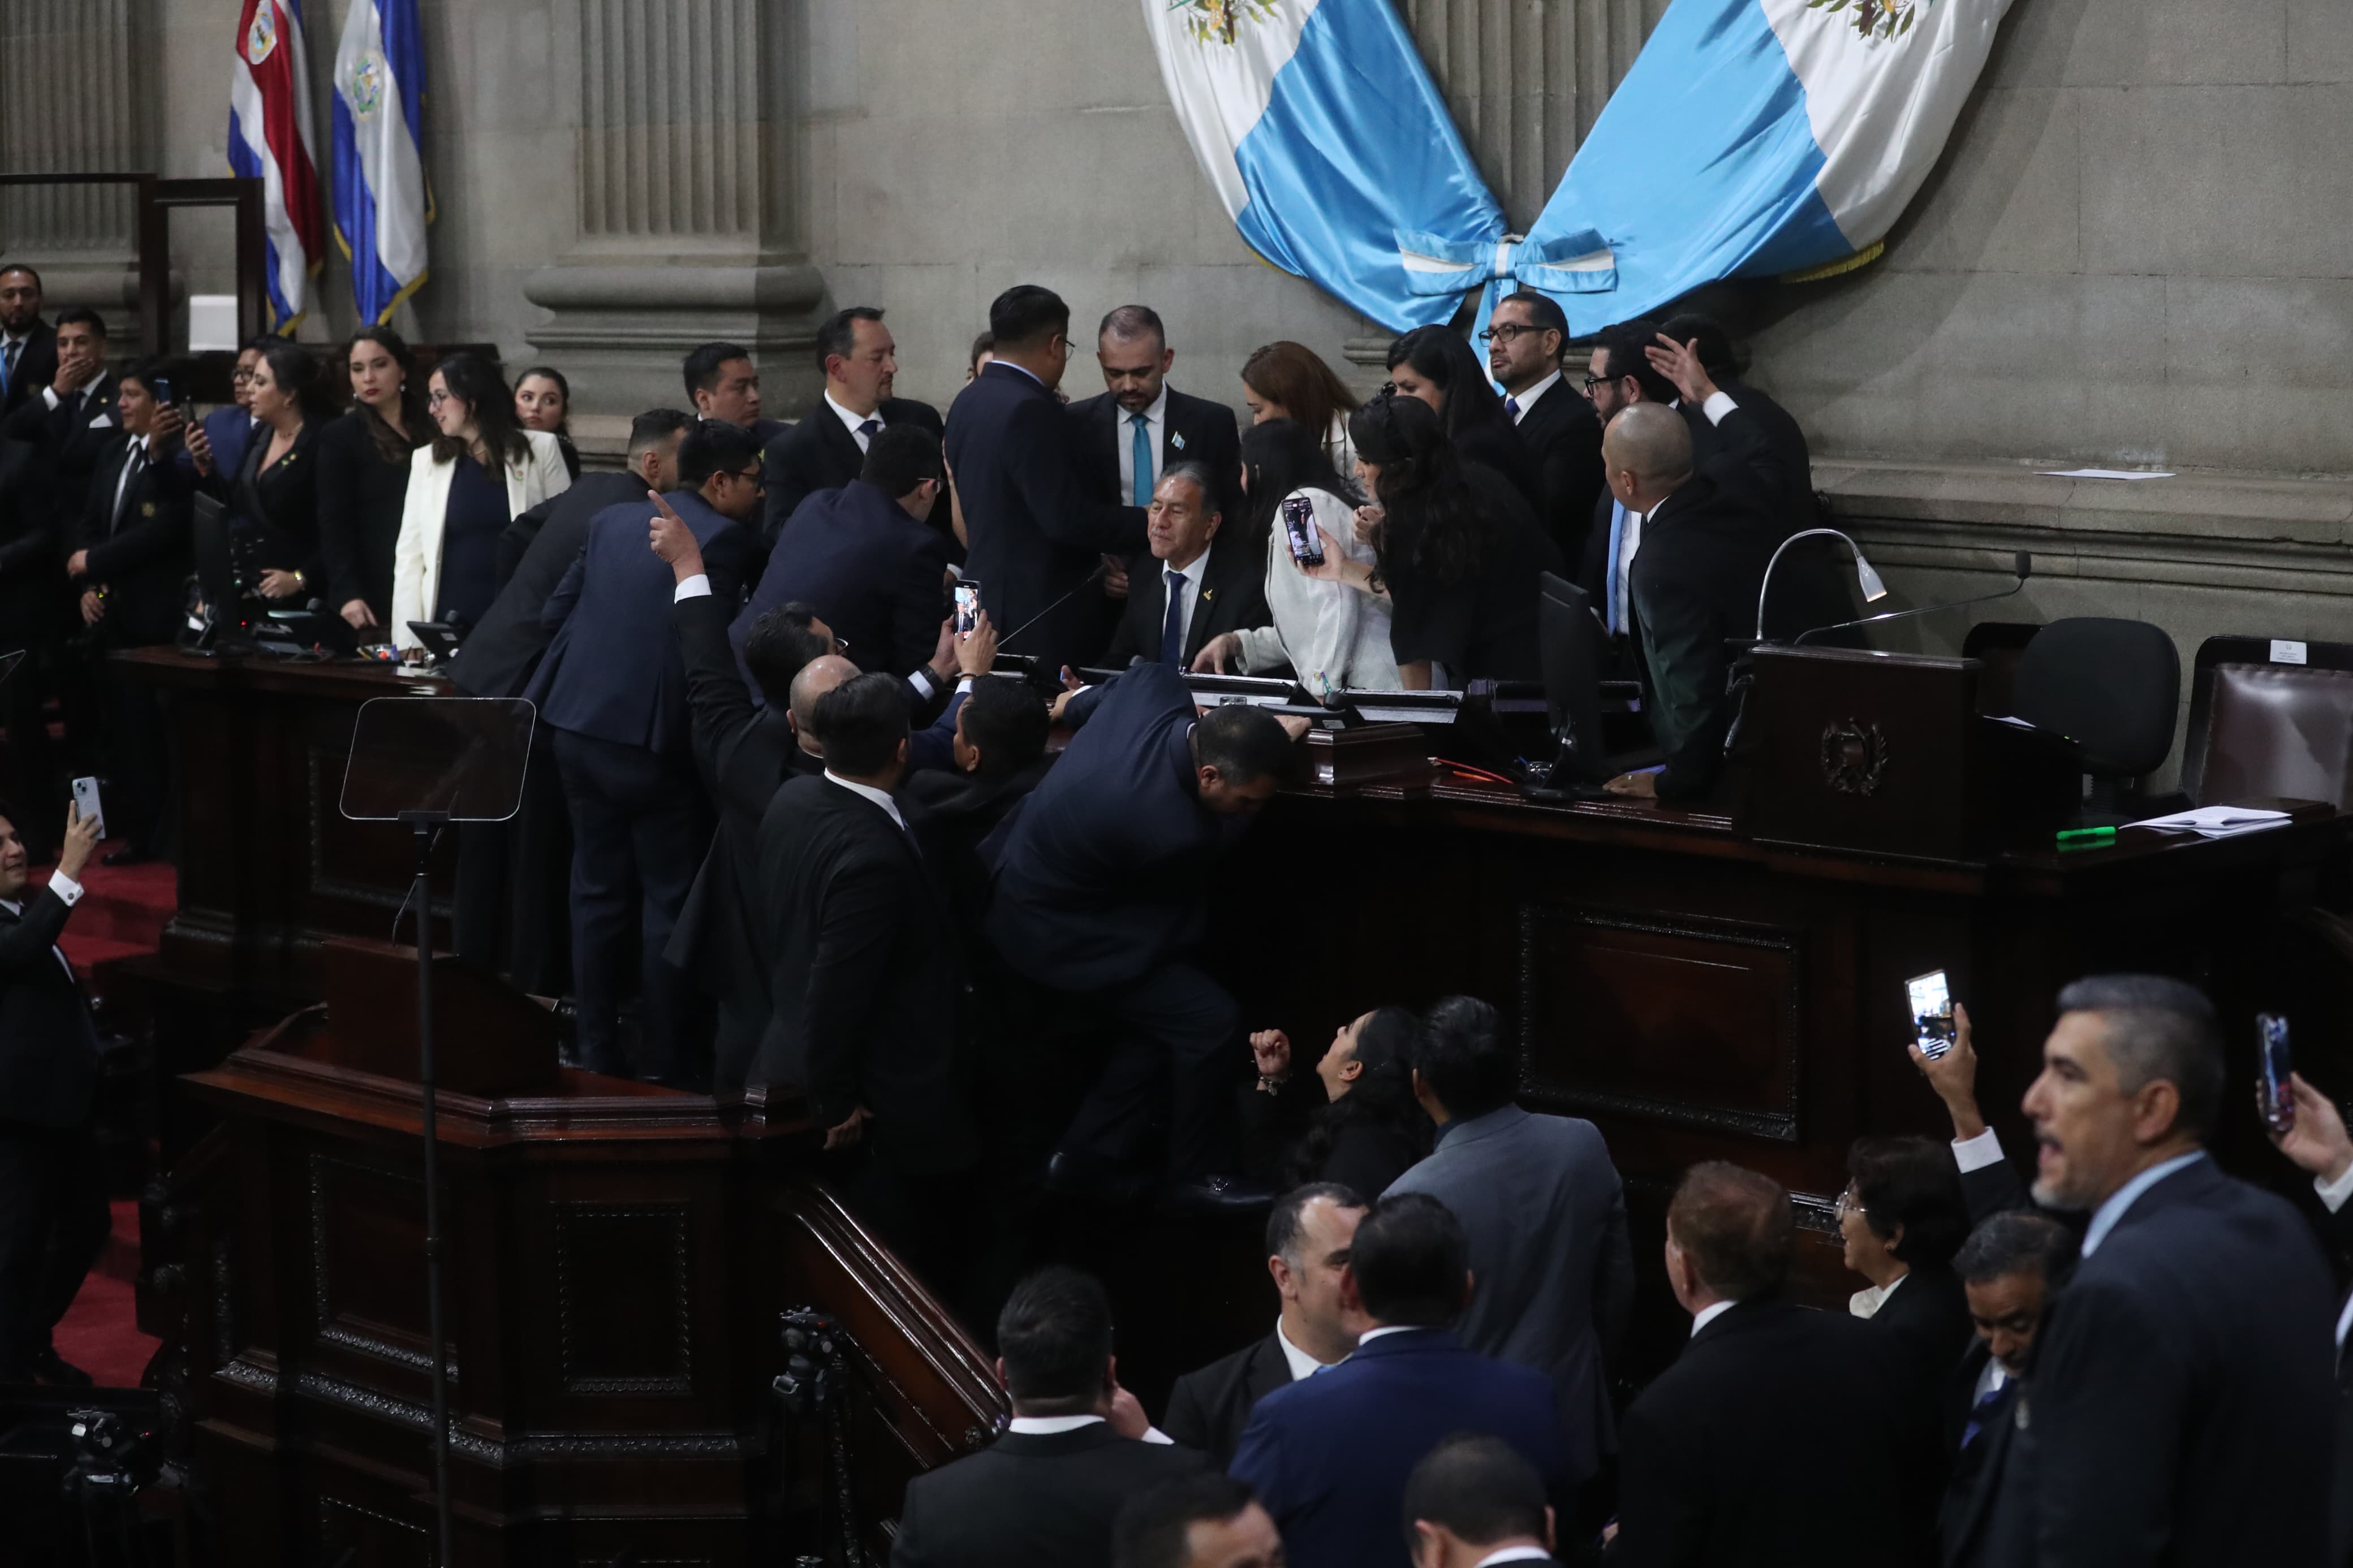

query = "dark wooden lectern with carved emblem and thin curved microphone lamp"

[{"left": 1734, "top": 646, "right": 2083, "bottom": 861}]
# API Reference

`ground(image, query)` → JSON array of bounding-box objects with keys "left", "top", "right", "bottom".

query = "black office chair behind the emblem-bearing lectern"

[{"left": 2010, "top": 616, "right": 2181, "bottom": 820}]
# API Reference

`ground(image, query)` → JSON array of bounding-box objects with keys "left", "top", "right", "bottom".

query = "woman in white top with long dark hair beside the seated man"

[{"left": 1193, "top": 418, "right": 1398, "bottom": 698}]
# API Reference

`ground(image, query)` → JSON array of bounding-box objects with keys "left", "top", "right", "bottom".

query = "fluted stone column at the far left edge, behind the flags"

[{"left": 0, "top": 0, "right": 153, "bottom": 329}]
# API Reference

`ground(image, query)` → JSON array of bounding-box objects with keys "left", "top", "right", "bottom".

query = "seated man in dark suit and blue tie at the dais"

[{"left": 1104, "top": 461, "right": 1270, "bottom": 670}]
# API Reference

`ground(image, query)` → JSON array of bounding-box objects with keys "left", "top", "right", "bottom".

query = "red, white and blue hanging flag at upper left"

[{"left": 229, "top": 0, "right": 327, "bottom": 331}]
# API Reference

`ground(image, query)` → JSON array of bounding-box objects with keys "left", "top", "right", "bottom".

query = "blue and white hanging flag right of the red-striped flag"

[{"left": 334, "top": 0, "right": 433, "bottom": 322}]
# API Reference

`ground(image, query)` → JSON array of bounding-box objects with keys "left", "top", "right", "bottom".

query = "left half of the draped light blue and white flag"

[{"left": 1141, "top": 0, "right": 1503, "bottom": 331}]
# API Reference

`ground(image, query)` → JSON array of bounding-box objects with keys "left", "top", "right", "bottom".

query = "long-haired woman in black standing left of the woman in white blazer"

[{"left": 318, "top": 327, "right": 433, "bottom": 642}]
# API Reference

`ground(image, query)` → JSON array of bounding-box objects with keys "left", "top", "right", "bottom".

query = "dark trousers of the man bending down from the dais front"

[{"left": 1061, "top": 964, "right": 1242, "bottom": 1180}]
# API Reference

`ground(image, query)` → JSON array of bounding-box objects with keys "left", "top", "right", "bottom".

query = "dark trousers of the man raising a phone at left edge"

[{"left": 0, "top": 1121, "right": 111, "bottom": 1383}]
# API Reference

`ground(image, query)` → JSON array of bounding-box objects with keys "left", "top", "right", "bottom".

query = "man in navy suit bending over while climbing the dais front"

[{"left": 974, "top": 663, "right": 1292, "bottom": 1208}]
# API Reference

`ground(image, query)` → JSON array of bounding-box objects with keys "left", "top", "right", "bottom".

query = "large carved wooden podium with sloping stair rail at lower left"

[{"left": 161, "top": 940, "right": 1005, "bottom": 1568}]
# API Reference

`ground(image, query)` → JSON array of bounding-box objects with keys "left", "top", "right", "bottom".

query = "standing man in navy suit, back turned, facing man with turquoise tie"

[{"left": 948, "top": 284, "right": 1144, "bottom": 670}]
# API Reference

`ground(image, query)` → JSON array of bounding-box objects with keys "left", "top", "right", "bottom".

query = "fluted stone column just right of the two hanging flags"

[{"left": 525, "top": 0, "right": 826, "bottom": 414}]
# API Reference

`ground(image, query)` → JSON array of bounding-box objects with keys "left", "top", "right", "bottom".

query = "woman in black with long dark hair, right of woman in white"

[{"left": 1306, "top": 395, "right": 1560, "bottom": 691}]
